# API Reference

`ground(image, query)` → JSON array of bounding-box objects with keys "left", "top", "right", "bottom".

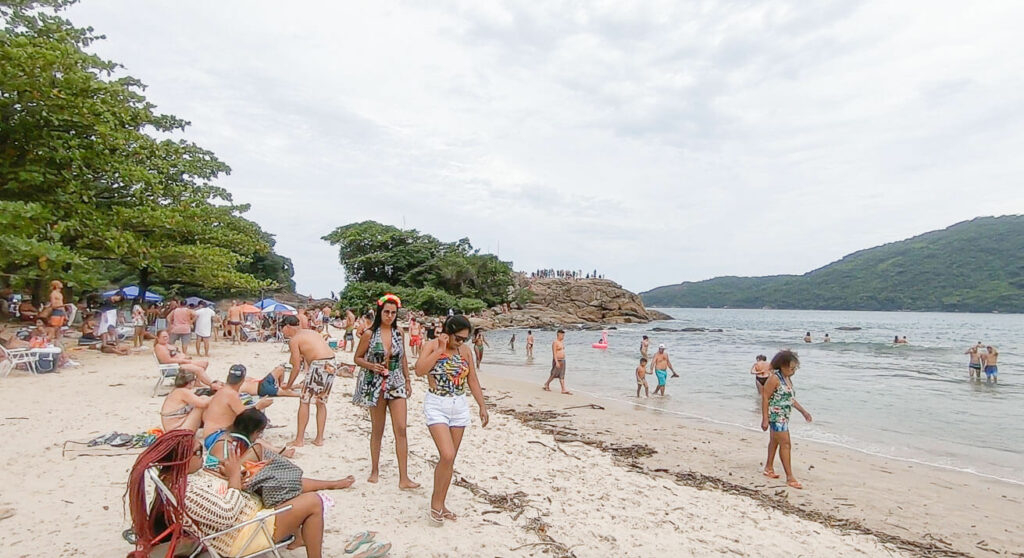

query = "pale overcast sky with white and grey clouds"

[{"left": 69, "top": 0, "right": 1024, "bottom": 296}]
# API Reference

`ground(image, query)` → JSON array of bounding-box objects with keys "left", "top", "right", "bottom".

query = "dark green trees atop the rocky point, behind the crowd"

[{"left": 324, "top": 221, "right": 513, "bottom": 313}]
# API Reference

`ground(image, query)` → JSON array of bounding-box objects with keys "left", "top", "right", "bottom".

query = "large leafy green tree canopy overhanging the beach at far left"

[{"left": 0, "top": 0, "right": 291, "bottom": 301}]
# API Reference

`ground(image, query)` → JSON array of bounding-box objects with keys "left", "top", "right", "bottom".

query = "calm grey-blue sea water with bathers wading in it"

[{"left": 483, "top": 308, "right": 1024, "bottom": 484}]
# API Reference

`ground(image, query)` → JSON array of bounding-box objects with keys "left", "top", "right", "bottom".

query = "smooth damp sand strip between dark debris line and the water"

[{"left": 480, "top": 361, "right": 1024, "bottom": 556}]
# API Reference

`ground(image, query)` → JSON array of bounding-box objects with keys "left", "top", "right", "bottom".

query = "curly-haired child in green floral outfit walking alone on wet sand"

[{"left": 761, "top": 350, "right": 811, "bottom": 488}]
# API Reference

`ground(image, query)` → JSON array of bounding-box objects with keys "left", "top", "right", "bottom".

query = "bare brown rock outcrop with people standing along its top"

[{"left": 479, "top": 278, "right": 668, "bottom": 328}]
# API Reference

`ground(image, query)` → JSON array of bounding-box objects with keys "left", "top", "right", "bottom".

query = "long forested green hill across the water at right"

[{"left": 640, "top": 215, "right": 1024, "bottom": 312}]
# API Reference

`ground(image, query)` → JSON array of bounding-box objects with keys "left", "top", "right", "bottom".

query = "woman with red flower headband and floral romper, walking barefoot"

[{"left": 352, "top": 293, "right": 419, "bottom": 488}]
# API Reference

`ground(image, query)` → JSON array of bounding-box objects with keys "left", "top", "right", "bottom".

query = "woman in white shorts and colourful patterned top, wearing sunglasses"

[{"left": 416, "top": 315, "right": 488, "bottom": 525}]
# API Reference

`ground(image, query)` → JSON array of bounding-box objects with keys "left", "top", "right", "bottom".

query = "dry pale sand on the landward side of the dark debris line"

[{"left": 0, "top": 343, "right": 913, "bottom": 557}]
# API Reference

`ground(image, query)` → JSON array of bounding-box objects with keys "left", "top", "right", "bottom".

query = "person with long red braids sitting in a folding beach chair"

[{"left": 126, "top": 430, "right": 324, "bottom": 558}]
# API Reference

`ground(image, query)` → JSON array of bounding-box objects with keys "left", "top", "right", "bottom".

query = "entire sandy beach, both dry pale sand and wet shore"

[{"left": 0, "top": 342, "right": 1007, "bottom": 557}]
